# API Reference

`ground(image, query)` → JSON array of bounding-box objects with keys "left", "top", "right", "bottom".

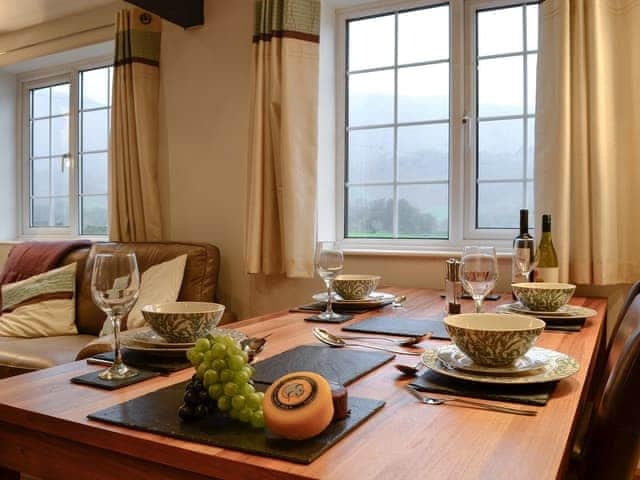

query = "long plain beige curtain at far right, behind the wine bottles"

[{"left": 535, "top": 0, "right": 640, "bottom": 285}]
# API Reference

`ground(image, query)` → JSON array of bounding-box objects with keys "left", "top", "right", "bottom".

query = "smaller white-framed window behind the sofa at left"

[{"left": 22, "top": 61, "right": 113, "bottom": 236}]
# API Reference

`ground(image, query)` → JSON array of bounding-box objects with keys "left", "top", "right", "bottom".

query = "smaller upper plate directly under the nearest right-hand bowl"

[{"left": 438, "top": 345, "right": 546, "bottom": 375}]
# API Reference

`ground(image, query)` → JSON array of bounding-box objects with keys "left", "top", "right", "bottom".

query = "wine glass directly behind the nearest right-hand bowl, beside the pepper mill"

[{"left": 460, "top": 247, "right": 498, "bottom": 313}]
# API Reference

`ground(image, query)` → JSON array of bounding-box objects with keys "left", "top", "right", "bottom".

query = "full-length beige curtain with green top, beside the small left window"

[{"left": 109, "top": 8, "right": 162, "bottom": 242}]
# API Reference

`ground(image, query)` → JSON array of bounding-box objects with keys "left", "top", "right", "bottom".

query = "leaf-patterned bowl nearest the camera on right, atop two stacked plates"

[{"left": 444, "top": 313, "right": 545, "bottom": 367}]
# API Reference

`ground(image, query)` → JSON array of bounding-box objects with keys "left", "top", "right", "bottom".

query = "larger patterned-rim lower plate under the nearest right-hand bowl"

[{"left": 422, "top": 347, "right": 580, "bottom": 385}]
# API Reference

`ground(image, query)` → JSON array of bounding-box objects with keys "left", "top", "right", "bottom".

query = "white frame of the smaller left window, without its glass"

[{"left": 16, "top": 56, "right": 113, "bottom": 240}]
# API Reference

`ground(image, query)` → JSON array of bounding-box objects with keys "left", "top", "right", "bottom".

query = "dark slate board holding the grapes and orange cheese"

[{"left": 88, "top": 382, "right": 384, "bottom": 464}]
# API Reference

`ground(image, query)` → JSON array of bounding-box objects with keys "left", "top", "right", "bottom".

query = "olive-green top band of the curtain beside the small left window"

[{"left": 114, "top": 8, "right": 162, "bottom": 66}]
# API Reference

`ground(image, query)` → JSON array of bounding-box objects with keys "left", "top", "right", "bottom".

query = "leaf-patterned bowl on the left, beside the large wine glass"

[{"left": 142, "top": 302, "right": 225, "bottom": 343}]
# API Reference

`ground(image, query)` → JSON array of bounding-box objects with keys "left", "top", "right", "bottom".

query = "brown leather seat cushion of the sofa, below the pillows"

[{"left": 0, "top": 335, "right": 96, "bottom": 372}]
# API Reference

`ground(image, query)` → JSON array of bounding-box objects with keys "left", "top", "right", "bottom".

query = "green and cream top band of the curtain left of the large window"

[{"left": 253, "top": 0, "right": 320, "bottom": 43}]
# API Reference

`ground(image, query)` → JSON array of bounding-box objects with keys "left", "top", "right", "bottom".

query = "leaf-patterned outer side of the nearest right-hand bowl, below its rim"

[{"left": 445, "top": 324, "right": 544, "bottom": 367}]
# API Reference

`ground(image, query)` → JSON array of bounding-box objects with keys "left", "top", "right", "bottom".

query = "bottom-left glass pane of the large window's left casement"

[{"left": 346, "top": 186, "right": 393, "bottom": 238}]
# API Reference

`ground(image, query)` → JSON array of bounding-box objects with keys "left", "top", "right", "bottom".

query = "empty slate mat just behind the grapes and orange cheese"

[{"left": 253, "top": 345, "right": 394, "bottom": 385}]
